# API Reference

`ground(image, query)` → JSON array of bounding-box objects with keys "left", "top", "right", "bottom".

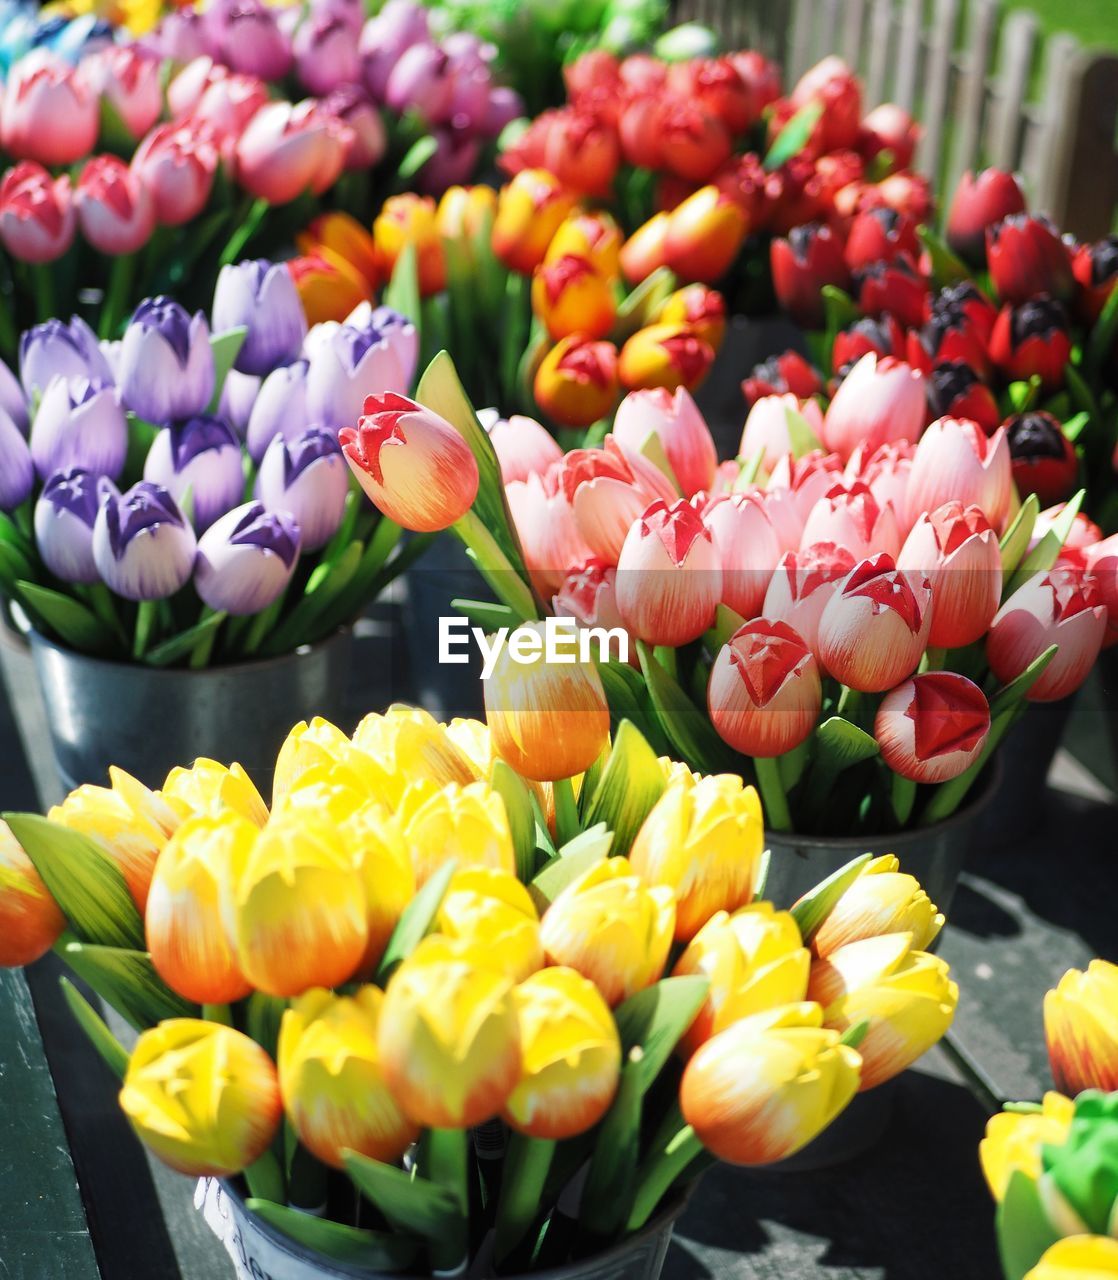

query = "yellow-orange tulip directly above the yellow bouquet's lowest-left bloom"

[{"left": 145, "top": 809, "right": 257, "bottom": 1005}]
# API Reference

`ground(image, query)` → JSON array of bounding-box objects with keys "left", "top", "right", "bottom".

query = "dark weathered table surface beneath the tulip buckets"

[{"left": 0, "top": 611, "right": 1118, "bottom": 1280}]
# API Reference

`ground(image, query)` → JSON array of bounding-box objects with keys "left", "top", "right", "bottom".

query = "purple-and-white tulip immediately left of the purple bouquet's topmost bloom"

[{"left": 119, "top": 297, "right": 214, "bottom": 426}]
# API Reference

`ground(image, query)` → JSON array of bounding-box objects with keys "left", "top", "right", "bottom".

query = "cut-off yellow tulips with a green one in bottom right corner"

[{"left": 980, "top": 960, "right": 1118, "bottom": 1280}]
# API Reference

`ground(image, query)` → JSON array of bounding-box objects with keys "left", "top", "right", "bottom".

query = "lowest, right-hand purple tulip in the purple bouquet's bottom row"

[{"left": 195, "top": 502, "right": 300, "bottom": 614}]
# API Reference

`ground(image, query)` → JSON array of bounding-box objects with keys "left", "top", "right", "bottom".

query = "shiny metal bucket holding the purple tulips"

[{"left": 29, "top": 630, "right": 352, "bottom": 796}]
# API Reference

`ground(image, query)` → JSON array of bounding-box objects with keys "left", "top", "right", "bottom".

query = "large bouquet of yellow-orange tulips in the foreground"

[{"left": 0, "top": 701, "right": 958, "bottom": 1275}]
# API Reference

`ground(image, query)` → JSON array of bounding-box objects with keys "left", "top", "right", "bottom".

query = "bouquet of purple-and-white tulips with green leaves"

[{"left": 0, "top": 261, "right": 424, "bottom": 667}]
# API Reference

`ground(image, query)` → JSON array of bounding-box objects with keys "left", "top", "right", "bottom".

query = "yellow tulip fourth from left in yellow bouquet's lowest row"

[{"left": 505, "top": 969, "right": 621, "bottom": 1139}]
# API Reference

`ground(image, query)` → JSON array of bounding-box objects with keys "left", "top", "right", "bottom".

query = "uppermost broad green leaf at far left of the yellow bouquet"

[{"left": 4, "top": 813, "right": 143, "bottom": 947}]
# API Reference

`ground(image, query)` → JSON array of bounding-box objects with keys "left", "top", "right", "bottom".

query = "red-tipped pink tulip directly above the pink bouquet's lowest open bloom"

[{"left": 896, "top": 502, "right": 1001, "bottom": 649}]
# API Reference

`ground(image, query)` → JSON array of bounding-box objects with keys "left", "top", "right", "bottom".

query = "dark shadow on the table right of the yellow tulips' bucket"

[{"left": 665, "top": 1071, "right": 999, "bottom": 1280}]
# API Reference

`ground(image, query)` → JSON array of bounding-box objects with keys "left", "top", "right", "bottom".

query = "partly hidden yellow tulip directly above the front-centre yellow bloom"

[{"left": 438, "top": 867, "right": 543, "bottom": 982}]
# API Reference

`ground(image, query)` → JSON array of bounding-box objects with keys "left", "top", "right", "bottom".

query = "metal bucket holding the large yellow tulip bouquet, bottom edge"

[{"left": 202, "top": 1178, "right": 686, "bottom": 1280}]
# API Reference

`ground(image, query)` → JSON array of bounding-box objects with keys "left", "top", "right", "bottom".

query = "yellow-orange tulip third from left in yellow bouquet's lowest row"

[{"left": 378, "top": 937, "right": 520, "bottom": 1129}]
